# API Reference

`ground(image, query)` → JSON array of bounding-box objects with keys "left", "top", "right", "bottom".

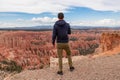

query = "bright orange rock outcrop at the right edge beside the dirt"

[{"left": 100, "top": 32, "right": 120, "bottom": 52}]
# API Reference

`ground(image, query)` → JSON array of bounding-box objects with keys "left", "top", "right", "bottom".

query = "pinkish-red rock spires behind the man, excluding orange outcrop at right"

[{"left": 0, "top": 31, "right": 99, "bottom": 69}]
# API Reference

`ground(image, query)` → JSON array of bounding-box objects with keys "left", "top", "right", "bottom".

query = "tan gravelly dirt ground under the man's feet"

[{"left": 4, "top": 54, "right": 120, "bottom": 80}]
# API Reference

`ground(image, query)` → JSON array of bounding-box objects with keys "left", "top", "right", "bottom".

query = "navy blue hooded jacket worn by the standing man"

[{"left": 52, "top": 20, "right": 71, "bottom": 45}]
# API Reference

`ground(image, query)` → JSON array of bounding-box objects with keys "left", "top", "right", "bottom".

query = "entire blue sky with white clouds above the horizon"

[{"left": 0, "top": 0, "right": 120, "bottom": 28}]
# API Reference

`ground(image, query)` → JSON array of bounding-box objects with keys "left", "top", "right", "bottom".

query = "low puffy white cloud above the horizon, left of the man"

[{"left": 0, "top": 16, "right": 57, "bottom": 28}]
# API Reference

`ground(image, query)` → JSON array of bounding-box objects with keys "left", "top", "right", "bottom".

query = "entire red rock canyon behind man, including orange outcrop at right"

[{"left": 0, "top": 29, "right": 120, "bottom": 70}]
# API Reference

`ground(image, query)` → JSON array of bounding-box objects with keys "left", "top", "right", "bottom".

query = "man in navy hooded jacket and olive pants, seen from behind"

[{"left": 52, "top": 13, "right": 74, "bottom": 75}]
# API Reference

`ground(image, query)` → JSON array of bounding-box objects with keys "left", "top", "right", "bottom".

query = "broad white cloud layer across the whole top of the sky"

[{"left": 0, "top": 0, "right": 120, "bottom": 13}]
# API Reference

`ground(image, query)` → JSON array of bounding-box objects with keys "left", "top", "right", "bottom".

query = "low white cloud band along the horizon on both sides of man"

[{"left": 0, "top": 17, "right": 120, "bottom": 28}]
